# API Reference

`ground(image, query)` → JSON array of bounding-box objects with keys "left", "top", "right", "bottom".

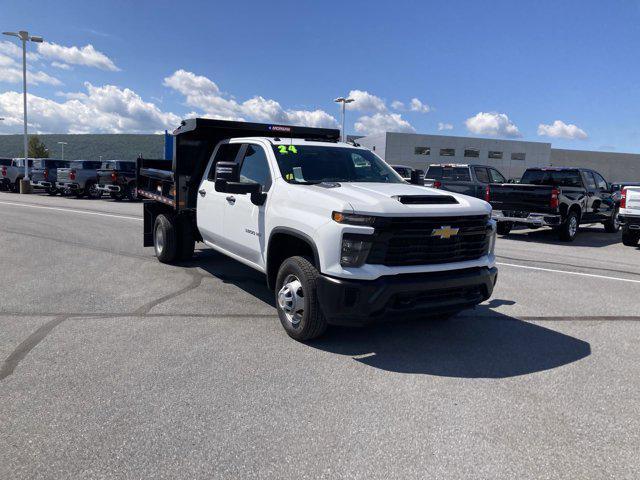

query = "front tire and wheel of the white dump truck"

[{"left": 275, "top": 257, "right": 327, "bottom": 342}]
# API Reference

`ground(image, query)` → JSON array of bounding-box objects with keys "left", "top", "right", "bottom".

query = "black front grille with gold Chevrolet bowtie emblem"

[{"left": 367, "top": 215, "right": 491, "bottom": 267}]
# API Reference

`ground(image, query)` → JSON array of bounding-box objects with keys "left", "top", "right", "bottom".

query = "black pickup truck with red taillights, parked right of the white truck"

[{"left": 486, "top": 167, "right": 620, "bottom": 241}]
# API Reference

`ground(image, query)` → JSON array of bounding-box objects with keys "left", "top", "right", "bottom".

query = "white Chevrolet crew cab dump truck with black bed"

[{"left": 137, "top": 118, "right": 497, "bottom": 340}]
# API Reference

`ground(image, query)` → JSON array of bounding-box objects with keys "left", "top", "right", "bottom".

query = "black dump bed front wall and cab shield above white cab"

[{"left": 172, "top": 118, "right": 340, "bottom": 209}]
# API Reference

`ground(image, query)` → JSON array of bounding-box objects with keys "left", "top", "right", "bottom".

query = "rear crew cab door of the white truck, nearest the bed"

[{"left": 196, "top": 143, "right": 241, "bottom": 249}]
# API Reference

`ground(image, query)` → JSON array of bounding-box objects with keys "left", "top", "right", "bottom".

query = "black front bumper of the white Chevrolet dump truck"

[{"left": 317, "top": 267, "right": 498, "bottom": 325}]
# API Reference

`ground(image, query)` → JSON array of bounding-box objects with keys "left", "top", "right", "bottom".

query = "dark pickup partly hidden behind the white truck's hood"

[{"left": 424, "top": 164, "right": 507, "bottom": 199}]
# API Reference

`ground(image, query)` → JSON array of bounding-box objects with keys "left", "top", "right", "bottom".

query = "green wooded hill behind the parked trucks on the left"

[{"left": 0, "top": 134, "right": 164, "bottom": 160}]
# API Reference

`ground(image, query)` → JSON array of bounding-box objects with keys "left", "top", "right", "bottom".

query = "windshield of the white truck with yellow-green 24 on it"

[{"left": 273, "top": 145, "right": 404, "bottom": 183}]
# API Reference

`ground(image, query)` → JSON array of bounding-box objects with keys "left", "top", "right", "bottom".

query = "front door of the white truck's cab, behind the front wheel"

[{"left": 224, "top": 143, "right": 273, "bottom": 268}]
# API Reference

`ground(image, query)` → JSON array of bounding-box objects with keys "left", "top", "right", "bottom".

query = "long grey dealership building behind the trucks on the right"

[{"left": 356, "top": 132, "right": 640, "bottom": 182}]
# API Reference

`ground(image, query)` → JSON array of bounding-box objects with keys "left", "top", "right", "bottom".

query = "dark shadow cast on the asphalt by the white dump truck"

[{"left": 182, "top": 250, "right": 591, "bottom": 378}]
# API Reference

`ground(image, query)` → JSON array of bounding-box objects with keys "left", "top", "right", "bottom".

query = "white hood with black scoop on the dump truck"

[{"left": 306, "top": 182, "right": 491, "bottom": 216}]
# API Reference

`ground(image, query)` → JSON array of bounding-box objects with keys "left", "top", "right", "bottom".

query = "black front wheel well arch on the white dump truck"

[{"left": 267, "top": 227, "right": 320, "bottom": 289}]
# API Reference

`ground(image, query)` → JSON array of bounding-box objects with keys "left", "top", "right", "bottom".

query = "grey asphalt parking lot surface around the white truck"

[{"left": 0, "top": 189, "right": 640, "bottom": 479}]
